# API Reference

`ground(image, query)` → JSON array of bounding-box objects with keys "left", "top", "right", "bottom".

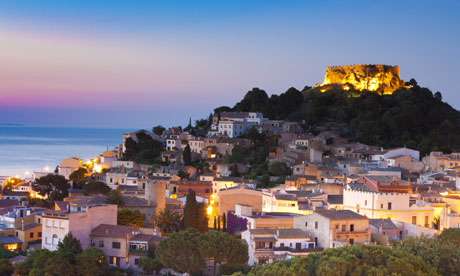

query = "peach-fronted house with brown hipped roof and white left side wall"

[{"left": 294, "top": 209, "right": 371, "bottom": 248}]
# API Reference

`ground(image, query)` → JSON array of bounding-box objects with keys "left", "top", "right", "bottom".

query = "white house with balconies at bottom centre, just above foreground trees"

[{"left": 241, "top": 228, "right": 322, "bottom": 265}]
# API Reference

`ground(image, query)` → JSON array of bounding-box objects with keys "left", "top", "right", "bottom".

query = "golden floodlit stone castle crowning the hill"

[{"left": 317, "top": 64, "right": 404, "bottom": 94}]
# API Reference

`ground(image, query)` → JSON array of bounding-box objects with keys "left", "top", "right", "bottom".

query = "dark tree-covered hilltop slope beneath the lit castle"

[{"left": 215, "top": 79, "right": 460, "bottom": 155}]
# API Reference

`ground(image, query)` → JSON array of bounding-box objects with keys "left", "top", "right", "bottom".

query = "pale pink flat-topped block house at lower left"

[{"left": 42, "top": 203, "right": 117, "bottom": 251}]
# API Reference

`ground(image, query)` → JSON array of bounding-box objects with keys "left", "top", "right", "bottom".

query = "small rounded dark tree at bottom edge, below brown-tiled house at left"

[{"left": 77, "top": 248, "right": 110, "bottom": 276}]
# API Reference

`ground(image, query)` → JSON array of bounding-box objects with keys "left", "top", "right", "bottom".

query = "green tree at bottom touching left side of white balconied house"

[{"left": 201, "top": 231, "right": 249, "bottom": 275}]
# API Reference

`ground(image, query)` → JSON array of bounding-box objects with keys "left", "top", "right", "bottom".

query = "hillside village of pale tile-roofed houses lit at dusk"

[{"left": 0, "top": 111, "right": 460, "bottom": 275}]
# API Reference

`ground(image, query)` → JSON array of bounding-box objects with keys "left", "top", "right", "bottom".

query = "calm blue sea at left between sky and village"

[{"left": 0, "top": 125, "right": 134, "bottom": 178}]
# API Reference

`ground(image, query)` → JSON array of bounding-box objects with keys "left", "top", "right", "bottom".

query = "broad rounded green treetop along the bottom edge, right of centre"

[{"left": 243, "top": 245, "right": 436, "bottom": 276}]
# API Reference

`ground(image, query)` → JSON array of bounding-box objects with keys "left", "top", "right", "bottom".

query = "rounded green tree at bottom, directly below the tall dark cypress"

[{"left": 155, "top": 228, "right": 205, "bottom": 275}]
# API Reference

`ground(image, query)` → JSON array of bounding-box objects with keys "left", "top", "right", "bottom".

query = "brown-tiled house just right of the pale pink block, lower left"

[{"left": 89, "top": 224, "right": 161, "bottom": 270}]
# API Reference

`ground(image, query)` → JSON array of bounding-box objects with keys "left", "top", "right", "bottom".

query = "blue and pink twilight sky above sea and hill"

[{"left": 0, "top": 0, "right": 460, "bottom": 128}]
